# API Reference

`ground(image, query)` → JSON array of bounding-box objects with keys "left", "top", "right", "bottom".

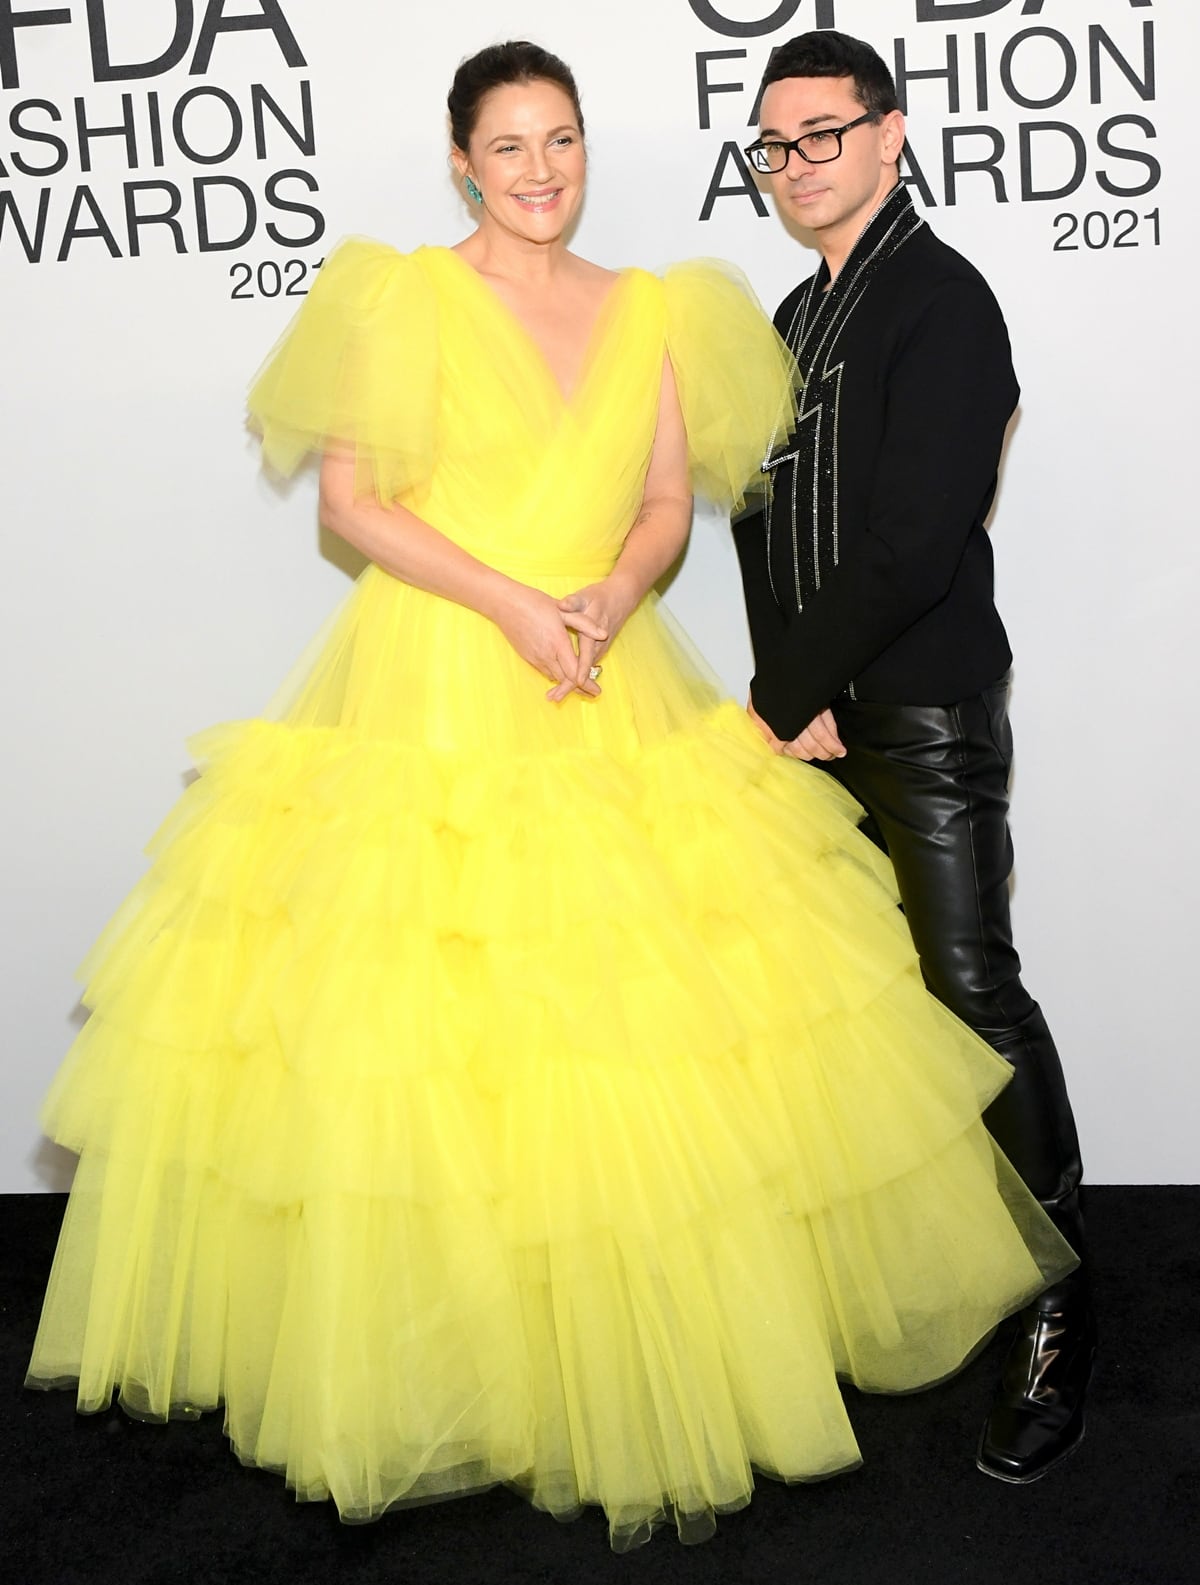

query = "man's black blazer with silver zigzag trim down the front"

[{"left": 736, "top": 187, "right": 1019, "bottom": 740}]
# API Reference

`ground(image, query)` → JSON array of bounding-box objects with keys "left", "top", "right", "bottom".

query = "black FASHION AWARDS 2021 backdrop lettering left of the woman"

[{"left": 0, "top": 0, "right": 325, "bottom": 296}]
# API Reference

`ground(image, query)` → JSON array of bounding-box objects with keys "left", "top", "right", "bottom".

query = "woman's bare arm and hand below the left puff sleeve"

[{"left": 320, "top": 452, "right": 607, "bottom": 693}]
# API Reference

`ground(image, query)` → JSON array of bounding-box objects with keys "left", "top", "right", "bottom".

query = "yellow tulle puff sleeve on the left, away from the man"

[{"left": 249, "top": 239, "right": 438, "bottom": 502}]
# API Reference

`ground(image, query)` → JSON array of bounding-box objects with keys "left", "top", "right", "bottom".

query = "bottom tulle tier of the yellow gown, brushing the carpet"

[{"left": 30, "top": 1113, "right": 1054, "bottom": 1550}]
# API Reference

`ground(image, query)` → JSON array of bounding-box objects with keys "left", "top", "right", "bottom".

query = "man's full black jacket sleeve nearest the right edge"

[{"left": 750, "top": 279, "right": 1019, "bottom": 742}]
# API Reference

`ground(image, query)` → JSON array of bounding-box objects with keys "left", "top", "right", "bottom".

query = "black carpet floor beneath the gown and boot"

[{"left": 0, "top": 1189, "right": 1200, "bottom": 1585}]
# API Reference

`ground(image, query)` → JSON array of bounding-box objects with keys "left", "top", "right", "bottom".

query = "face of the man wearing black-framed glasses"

[{"left": 759, "top": 78, "right": 904, "bottom": 241}]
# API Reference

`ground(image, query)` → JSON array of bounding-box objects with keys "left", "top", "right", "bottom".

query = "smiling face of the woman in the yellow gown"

[{"left": 455, "top": 79, "right": 587, "bottom": 243}]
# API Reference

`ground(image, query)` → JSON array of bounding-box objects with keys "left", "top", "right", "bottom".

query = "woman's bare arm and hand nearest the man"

[{"left": 547, "top": 360, "right": 691, "bottom": 699}]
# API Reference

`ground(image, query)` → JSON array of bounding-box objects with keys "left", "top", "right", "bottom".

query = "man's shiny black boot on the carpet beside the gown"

[{"left": 975, "top": 1195, "right": 1095, "bottom": 1485}]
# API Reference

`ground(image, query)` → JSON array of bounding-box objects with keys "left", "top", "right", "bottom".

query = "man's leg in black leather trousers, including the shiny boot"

[{"left": 824, "top": 680, "right": 1095, "bottom": 1484}]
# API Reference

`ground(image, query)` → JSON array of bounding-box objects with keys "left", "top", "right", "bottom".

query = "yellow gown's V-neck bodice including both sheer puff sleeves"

[{"left": 250, "top": 241, "right": 793, "bottom": 575}]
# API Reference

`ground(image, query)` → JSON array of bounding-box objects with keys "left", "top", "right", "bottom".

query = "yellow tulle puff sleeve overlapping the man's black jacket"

[{"left": 663, "top": 258, "right": 799, "bottom": 510}]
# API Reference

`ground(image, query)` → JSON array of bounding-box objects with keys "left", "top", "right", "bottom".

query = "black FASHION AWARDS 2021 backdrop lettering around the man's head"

[{"left": 686, "top": 0, "right": 1162, "bottom": 252}]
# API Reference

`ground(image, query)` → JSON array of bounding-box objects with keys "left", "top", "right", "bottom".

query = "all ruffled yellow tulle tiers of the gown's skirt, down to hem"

[{"left": 30, "top": 687, "right": 1068, "bottom": 1545}]
